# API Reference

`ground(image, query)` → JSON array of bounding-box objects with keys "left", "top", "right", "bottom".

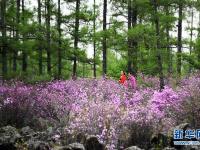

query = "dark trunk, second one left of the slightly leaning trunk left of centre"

[{"left": 46, "top": 0, "right": 51, "bottom": 74}]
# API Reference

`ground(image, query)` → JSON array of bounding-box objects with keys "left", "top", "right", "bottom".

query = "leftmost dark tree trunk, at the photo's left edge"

[{"left": 1, "top": 0, "right": 7, "bottom": 78}]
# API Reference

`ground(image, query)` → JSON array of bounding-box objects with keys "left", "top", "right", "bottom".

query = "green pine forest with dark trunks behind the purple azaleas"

[{"left": 0, "top": 0, "right": 200, "bottom": 89}]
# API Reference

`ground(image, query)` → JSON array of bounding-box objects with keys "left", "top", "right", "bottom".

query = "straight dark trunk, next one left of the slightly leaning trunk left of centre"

[{"left": 57, "top": 0, "right": 62, "bottom": 78}]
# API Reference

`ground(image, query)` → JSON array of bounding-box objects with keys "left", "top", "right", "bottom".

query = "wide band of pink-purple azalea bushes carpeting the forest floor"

[{"left": 0, "top": 75, "right": 200, "bottom": 149}]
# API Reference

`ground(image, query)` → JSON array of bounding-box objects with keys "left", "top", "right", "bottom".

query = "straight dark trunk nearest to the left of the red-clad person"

[{"left": 103, "top": 0, "right": 107, "bottom": 76}]
